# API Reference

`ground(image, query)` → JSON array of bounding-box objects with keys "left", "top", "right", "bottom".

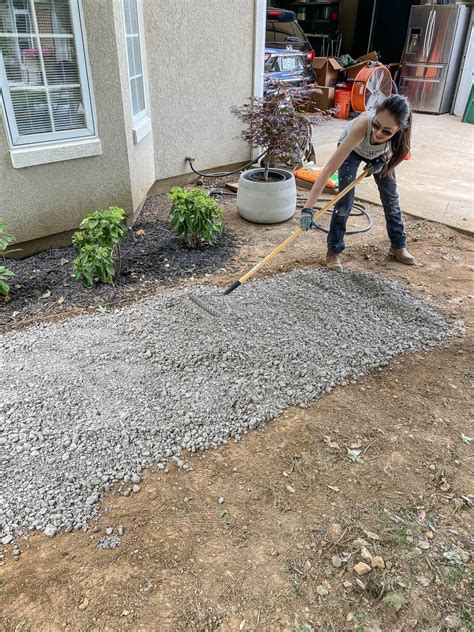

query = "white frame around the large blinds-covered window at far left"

[{"left": 0, "top": 0, "right": 96, "bottom": 148}]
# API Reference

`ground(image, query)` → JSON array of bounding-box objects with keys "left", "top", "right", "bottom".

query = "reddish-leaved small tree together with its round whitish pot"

[{"left": 231, "top": 82, "right": 328, "bottom": 224}]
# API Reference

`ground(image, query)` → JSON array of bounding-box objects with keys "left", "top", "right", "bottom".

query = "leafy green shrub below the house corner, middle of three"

[{"left": 72, "top": 206, "right": 127, "bottom": 287}]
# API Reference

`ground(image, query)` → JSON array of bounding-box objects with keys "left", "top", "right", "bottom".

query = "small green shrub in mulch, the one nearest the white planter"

[{"left": 168, "top": 187, "right": 223, "bottom": 248}]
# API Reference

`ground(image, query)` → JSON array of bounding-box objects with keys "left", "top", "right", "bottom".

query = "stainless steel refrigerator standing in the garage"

[{"left": 399, "top": 4, "right": 471, "bottom": 114}]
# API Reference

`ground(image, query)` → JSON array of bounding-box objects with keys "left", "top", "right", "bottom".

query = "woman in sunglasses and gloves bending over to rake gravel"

[{"left": 300, "top": 94, "right": 415, "bottom": 272}]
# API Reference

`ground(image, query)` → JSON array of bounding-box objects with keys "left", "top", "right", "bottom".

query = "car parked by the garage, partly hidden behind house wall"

[{"left": 264, "top": 7, "right": 316, "bottom": 94}]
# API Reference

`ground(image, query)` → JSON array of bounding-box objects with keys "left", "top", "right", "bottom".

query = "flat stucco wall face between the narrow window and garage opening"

[{"left": 143, "top": 0, "right": 259, "bottom": 180}]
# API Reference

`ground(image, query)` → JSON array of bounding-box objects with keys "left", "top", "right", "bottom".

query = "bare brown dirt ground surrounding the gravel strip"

[{"left": 0, "top": 180, "right": 474, "bottom": 632}]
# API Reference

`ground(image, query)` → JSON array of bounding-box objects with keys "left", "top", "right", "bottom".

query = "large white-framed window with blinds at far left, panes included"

[{"left": 0, "top": 0, "right": 94, "bottom": 144}]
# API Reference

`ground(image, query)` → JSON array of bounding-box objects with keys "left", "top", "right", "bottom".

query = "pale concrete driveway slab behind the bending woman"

[{"left": 313, "top": 113, "right": 474, "bottom": 233}]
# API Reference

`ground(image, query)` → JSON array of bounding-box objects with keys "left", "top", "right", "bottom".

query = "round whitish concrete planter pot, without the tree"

[{"left": 237, "top": 169, "right": 296, "bottom": 224}]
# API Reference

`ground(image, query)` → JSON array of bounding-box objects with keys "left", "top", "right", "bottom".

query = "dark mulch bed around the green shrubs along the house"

[{"left": 0, "top": 194, "right": 237, "bottom": 331}]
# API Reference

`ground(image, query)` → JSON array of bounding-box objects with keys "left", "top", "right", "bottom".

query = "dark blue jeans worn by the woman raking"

[{"left": 327, "top": 151, "right": 406, "bottom": 254}]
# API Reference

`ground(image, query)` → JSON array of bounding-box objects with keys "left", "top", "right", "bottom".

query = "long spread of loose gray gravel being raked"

[{"left": 0, "top": 270, "right": 449, "bottom": 538}]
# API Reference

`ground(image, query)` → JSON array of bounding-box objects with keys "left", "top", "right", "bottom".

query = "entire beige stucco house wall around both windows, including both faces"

[{"left": 0, "top": 0, "right": 265, "bottom": 249}]
